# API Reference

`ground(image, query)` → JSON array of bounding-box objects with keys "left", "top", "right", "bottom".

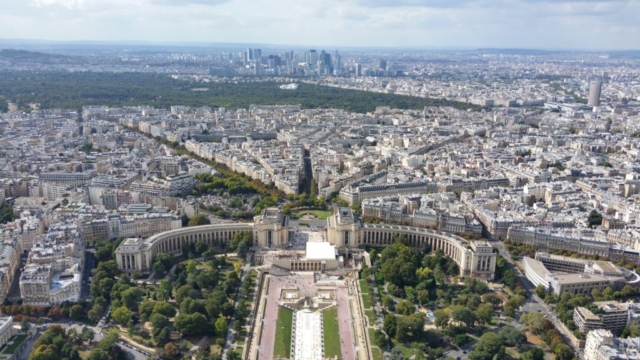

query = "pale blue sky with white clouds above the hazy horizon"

[{"left": 0, "top": 0, "right": 640, "bottom": 50}]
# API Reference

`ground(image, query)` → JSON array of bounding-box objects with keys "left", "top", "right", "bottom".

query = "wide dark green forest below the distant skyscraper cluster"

[{"left": 0, "top": 72, "right": 479, "bottom": 112}]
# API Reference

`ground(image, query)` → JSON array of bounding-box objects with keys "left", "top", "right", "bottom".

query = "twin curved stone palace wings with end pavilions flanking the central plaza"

[{"left": 116, "top": 208, "right": 497, "bottom": 279}]
